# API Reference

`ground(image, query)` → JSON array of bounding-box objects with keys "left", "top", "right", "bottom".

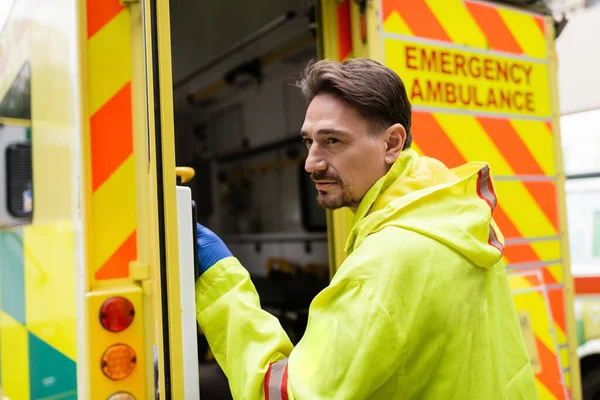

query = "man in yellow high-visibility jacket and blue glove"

[{"left": 196, "top": 59, "right": 538, "bottom": 400}]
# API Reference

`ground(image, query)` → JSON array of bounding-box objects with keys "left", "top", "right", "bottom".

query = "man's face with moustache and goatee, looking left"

[{"left": 301, "top": 94, "right": 390, "bottom": 211}]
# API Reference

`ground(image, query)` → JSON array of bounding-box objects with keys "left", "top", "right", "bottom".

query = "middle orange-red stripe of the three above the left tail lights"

[{"left": 90, "top": 83, "right": 133, "bottom": 191}]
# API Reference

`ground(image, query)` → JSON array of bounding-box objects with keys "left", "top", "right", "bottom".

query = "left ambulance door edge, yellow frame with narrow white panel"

[{"left": 140, "top": 0, "right": 199, "bottom": 400}]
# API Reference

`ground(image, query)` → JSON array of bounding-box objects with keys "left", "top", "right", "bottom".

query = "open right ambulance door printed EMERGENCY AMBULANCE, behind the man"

[{"left": 317, "top": 0, "right": 581, "bottom": 399}]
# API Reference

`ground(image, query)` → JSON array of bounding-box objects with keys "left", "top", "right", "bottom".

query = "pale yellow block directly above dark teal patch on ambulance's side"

[{"left": 23, "top": 222, "right": 77, "bottom": 361}]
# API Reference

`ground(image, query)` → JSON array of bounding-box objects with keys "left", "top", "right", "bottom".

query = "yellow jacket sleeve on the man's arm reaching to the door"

[{"left": 196, "top": 257, "right": 401, "bottom": 400}]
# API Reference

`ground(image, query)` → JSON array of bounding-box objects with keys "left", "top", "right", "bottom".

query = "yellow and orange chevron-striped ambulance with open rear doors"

[{"left": 0, "top": 0, "right": 582, "bottom": 400}]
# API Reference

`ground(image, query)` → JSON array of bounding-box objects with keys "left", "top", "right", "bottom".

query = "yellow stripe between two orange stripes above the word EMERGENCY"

[{"left": 425, "top": 0, "right": 489, "bottom": 49}]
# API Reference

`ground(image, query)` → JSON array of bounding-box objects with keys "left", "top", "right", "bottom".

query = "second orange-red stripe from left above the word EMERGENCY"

[{"left": 465, "top": 1, "right": 523, "bottom": 54}]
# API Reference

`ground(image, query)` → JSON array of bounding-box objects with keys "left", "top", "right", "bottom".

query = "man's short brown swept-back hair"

[{"left": 297, "top": 58, "right": 412, "bottom": 149}]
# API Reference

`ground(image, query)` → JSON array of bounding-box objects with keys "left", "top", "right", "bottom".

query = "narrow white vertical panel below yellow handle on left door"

[{"left": 177, "top": 186, "right": 200, "bottom": 400}]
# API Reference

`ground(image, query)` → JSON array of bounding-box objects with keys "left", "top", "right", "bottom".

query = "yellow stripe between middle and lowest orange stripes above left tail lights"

[{"left": 92, "top": 155, "right": 136, "bottom": 272}]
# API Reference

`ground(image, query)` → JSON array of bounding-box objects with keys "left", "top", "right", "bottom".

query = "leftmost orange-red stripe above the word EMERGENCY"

[{"left": 382, "top": 0, "right": 452, "bottom": 42}]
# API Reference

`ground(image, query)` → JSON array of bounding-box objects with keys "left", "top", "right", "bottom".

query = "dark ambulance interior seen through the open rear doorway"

[{"left": 171, "top": 0, "right": 329, "bottom": 399}]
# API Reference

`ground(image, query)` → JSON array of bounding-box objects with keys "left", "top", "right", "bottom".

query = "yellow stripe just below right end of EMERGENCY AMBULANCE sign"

[{"left": 510, "top": 119, "right": 555, "bottom": 176}]
